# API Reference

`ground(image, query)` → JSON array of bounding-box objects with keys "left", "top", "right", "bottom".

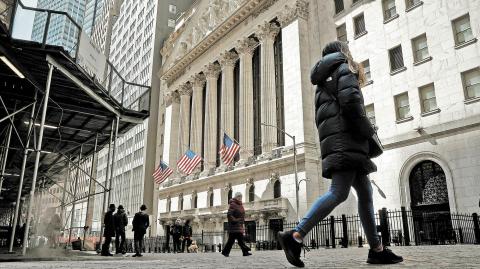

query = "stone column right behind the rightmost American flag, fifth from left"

[{"left": 218, "top": 51, "right": 238, "bottom": 171}]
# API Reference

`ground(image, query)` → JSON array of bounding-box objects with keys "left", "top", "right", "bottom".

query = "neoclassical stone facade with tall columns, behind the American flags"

[{"left": 157, "top": 0, "right": 318, "bottom": 234}]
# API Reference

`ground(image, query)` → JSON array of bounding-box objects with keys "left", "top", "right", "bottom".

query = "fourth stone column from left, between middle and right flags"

[{"left": 202, "top": 63, "right": 220, "bottom": 176}]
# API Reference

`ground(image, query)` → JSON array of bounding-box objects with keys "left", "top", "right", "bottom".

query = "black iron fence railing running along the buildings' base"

[{"left": 111, "top": 207, "right": 480, "bottom": 252}]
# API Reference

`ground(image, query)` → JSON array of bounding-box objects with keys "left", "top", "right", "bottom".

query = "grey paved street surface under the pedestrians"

[{"left": 0, "top": 245, "right": 480, "bottom": 269}]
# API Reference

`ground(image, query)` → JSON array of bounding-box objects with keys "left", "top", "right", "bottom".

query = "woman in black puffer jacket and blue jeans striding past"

[{"left": 278, "top": 41, "right": 403, "bottom": 267}]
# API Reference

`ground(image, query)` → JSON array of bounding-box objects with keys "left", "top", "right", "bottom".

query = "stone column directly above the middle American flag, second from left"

[{"left": 175, "top": 83, "right": 192, "bottom": 156}]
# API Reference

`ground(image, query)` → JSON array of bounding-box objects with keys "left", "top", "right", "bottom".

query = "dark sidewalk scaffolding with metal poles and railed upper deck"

[{"left": 0, "top": 0, "right": 151, "bottom": 255}]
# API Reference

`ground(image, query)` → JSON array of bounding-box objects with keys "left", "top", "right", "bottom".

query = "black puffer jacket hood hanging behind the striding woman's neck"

[{"left": 310, "top": 52, "right": 347, "bottom": 85}]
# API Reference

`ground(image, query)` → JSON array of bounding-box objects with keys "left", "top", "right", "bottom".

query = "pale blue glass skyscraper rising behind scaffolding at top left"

[{"left": 32, "top": 0, "right": 85, "bottom": 53}]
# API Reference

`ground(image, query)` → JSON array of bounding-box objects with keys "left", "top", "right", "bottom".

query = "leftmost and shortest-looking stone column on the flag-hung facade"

[{"left": 164, "top": 91, "right": 183, "bottom": 178}]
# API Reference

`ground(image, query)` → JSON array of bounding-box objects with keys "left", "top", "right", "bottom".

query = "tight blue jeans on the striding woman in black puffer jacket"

[{"left": 295, "top": 171, "right": 380, "bottom": 248}]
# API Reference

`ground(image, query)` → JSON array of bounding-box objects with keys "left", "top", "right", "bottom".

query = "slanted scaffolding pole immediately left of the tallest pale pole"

[{"left": 8, "top": 91, "right": 37, "bottom": 252}]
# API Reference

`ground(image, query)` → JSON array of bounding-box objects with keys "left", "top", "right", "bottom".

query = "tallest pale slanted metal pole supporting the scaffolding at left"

[{"left": 22, "top": 64, "right": 53, "bottom": 255}]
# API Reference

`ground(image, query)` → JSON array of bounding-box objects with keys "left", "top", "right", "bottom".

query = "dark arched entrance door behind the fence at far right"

[{"left": 410, "top": 161, "right": 456, "bottom": 245}]
